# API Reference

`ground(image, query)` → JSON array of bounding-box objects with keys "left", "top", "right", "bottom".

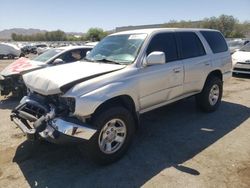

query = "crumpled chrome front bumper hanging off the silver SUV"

[{"left": 10, "top": 97, "right": 96, "bottom": 143}]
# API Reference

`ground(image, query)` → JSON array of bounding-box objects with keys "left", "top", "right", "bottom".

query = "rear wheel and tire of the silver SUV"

[{"left": 196, "top": 77, "right": 223, "bottom": 112}]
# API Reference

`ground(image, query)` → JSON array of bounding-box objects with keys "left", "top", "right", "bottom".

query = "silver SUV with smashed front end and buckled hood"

[{"left": 11, "top": 29, "right": 232, "bottom": 164}]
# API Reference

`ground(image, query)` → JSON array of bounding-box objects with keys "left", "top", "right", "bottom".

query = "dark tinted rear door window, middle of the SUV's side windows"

[{"left": 178, "top": 32, "right": 206, "bottom": 59}]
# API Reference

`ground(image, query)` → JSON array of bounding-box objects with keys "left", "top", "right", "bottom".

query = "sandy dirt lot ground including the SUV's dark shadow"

[{"left": 0, "top": 60, "right": 250, "bottom": 188}]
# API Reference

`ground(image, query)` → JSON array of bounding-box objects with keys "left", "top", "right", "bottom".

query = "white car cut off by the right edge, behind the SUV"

[{"left": 232, "top": 43, "right": 250, "bottom": 74}]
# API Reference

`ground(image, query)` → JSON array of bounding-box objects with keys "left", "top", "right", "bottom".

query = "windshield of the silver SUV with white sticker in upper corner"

[{"left": 86, "top": 34, "right": 147, "bottom": 64}]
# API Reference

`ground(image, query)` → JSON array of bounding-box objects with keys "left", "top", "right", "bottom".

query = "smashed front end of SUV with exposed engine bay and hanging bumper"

[{"left": 10, "top": 94, "right": 96, "bottom": 143}]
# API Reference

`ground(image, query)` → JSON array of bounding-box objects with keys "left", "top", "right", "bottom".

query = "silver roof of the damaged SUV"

[{"left": 112, "top": 28, "right": 217, "bottom": 35}]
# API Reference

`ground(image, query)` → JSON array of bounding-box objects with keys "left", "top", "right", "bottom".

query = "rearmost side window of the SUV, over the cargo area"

[{"left": 201, "top": 31, "right": 228, "bottom": 53}]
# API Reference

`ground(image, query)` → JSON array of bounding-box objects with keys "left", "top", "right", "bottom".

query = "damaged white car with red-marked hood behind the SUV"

[{"left": 0, "top": 45, "right": 94, "bottom": 97}]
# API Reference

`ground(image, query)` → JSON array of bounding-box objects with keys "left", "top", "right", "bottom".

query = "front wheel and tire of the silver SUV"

[{"left": 80, "top": 107, "right": 135, "bottom": 165}]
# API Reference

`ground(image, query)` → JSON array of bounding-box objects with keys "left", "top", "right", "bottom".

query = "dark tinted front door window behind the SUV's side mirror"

[{"left": 147, "top": 33, "right": 178, "bottom": 62}]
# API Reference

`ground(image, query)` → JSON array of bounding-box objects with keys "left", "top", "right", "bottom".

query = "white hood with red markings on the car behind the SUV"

[{"left": 1, "top": 57, "right": 46, "bottom": 76}]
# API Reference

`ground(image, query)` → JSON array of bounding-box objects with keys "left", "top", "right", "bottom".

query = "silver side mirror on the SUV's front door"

[{"left": 146, "top": 51, "right": 166, "bottom": 66}]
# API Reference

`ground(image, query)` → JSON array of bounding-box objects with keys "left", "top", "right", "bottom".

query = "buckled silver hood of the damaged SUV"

[{"left": 23, "top": 61, "right": 125, "bottom": 95}]
